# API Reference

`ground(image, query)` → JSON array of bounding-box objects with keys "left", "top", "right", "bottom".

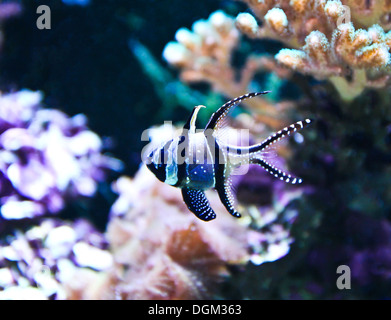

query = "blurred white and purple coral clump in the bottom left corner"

[{"left": 0, "top": 219, "right": 113, "bottom": 300}]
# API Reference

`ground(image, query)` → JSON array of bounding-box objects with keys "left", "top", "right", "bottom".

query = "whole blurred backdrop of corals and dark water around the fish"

[{"left": 0, "top": 0, "right": 391, "bottom": 299}]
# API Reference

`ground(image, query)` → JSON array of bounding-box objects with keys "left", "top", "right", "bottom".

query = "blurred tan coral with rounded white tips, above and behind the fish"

[{"left": 163, "top": 11, "right": 289, "bottom": 129}]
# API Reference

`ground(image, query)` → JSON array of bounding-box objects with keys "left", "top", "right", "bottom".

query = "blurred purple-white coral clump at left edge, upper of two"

[{"left": 0, "top": 90, "right": 119, "bottom": 219}]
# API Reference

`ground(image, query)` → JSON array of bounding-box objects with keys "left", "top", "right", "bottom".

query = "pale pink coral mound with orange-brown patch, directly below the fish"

[{"left": 107, "top": 167, "right": 247, "bottom": 299}]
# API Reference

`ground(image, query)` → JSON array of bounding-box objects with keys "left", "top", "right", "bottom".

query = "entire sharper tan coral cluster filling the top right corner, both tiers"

[{"left": 236, "top": 0, "right": 391, "bottom": 101}]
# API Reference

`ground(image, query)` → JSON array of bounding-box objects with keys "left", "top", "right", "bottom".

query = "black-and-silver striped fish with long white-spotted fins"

[{"left": 146, "top": 91, "right": 312, "bottom": 221}]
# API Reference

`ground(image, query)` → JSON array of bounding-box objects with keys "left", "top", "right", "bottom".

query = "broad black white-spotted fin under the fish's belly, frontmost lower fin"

[{"left": 182, "top": 188, "right": 216, "bottom": 221}]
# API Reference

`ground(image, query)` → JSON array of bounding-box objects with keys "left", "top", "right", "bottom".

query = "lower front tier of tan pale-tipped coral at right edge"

[{"left": 276, "top": 23, "right": 390, "bottom": 100}]
